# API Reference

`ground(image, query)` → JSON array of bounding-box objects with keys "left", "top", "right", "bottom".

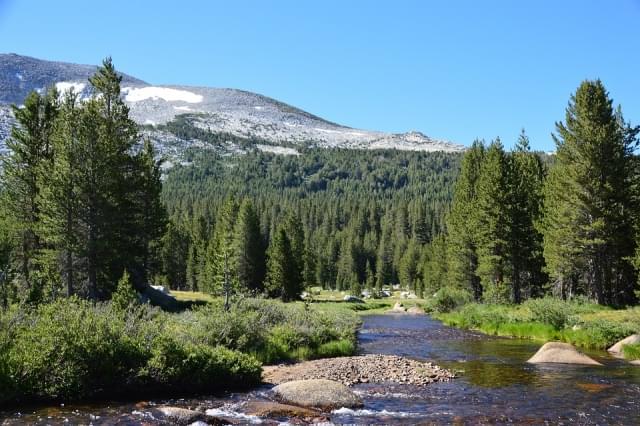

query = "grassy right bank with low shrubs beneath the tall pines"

[{"left": 432, "top": 298, "right": 640, "bottom": 359}]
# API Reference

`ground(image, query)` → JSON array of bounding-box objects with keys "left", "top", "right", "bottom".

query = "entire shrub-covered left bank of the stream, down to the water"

[{"left": 0, "top": 298, "right": 360, "bottom": 406}]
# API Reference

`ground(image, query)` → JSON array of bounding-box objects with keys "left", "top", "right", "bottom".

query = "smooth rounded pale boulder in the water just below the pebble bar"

[{"left": 273, "top": 379, "right": 364, "bottom": 410}]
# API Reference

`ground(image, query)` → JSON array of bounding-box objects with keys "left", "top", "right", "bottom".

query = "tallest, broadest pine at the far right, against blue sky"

[{"left": 544, "top": 80, "right": 638, "bottom": 305}]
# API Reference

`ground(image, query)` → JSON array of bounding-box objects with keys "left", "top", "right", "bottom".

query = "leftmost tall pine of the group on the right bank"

[{"left": 447, "top": 141, "right": 485, "bottom": 300}]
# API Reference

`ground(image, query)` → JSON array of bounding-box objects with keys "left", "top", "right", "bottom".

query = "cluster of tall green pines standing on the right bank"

[{"left": 425, "top": 80, "right": 640, "bottom": 305}]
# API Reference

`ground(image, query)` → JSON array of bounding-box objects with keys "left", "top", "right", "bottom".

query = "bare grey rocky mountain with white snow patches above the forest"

[{"left": 0, "top": 54, "right": 464, "bottom": 157}]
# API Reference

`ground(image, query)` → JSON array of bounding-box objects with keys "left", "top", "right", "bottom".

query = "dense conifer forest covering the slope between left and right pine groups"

[{"left": 157, "top": 149, "right": 460, "bottom": 299}]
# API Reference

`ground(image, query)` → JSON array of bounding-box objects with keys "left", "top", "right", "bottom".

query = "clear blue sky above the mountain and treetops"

[{"left": 0, "top": 0, "right": 640, "bottom": 150}]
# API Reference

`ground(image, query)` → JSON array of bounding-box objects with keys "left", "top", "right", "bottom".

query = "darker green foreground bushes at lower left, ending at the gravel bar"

[{"left": 0, "top": 298, "right": 260, "bottom": 404}]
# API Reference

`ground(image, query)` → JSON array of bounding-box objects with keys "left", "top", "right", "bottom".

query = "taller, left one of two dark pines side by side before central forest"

[{"left": 233, "top": 200, "right": 266, "bottom": 294}]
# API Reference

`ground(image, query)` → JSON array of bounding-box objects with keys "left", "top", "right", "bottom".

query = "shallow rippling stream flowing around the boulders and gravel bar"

[{"left": 0, "top": 315, "right": 640, "bottom": 425}]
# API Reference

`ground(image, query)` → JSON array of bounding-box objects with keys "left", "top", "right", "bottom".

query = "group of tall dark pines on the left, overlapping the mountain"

[{"left": 0, "top": 59, "right": 167, "bottom": 307}]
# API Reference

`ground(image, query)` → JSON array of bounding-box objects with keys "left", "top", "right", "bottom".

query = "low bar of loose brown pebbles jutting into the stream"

[{"left": 262, "top": 355, "right": 455, "bottom": 386}]
